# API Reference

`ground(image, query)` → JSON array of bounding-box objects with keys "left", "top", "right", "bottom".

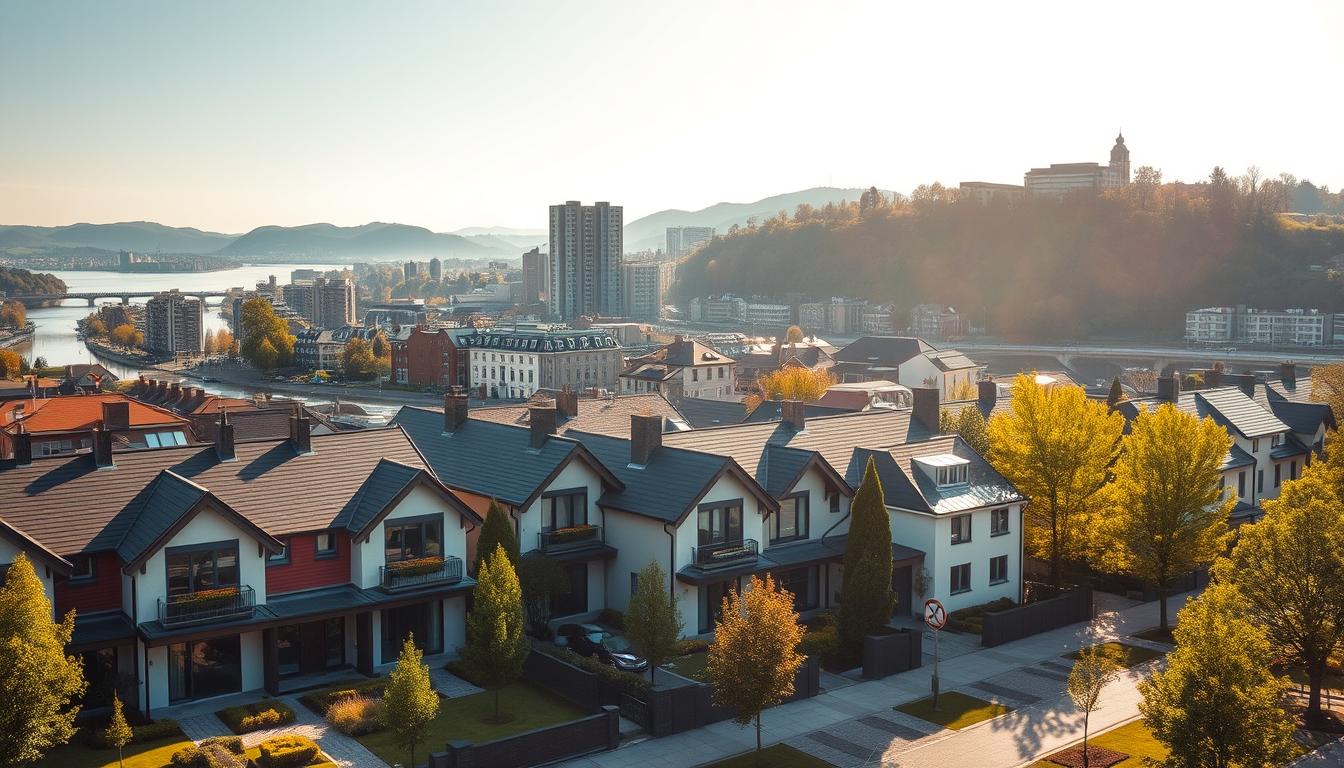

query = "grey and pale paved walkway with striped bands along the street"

[{"left": 562, "top": 594, "right": 1189, "bottom": 768}]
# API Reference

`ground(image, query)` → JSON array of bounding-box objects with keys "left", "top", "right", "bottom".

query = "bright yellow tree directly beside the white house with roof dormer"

[{"left": 988, "top": 374, "right": 1125, "bottom": 586}]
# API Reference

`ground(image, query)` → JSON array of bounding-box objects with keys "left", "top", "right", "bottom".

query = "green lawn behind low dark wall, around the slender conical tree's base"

[{"left": 359, "top": 683, "right": 583, "bottom": 764}]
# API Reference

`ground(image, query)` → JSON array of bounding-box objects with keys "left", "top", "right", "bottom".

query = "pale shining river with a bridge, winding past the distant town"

[{"left": 13, "top": 264, "right": 395, "bottom": 414}]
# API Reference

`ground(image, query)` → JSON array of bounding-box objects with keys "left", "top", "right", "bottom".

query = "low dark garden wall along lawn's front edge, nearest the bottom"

[{"left": 429, "top": 706, "right": 621, "bottom": 768}]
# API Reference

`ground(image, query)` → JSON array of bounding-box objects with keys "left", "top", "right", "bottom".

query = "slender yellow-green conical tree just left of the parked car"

[{"left": 462, "top": 546, "right": 530, "bottom": 722}]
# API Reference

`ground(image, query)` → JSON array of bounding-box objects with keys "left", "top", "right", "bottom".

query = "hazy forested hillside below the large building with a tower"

[{"left": 676, "top": 176, "right": 1344, "bottom": 339}]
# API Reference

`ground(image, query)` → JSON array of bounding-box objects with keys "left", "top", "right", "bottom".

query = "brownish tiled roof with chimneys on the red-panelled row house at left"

[{"left": 0, "top": 429, "right": 427, "bottom": 554}]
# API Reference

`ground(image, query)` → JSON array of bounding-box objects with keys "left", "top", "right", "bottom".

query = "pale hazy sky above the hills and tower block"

[{"left": 0, "top": 0, "right": 1344, "bottom": 231}]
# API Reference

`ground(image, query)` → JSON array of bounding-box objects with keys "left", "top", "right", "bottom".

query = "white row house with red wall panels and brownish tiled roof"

[{"left": 0, "top": 414, "right": 480, "bottom": 714}]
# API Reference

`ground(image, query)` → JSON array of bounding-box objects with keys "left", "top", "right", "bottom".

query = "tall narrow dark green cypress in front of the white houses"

[{"left": 839, "top": 457, "right": 892, "bottom": 656}]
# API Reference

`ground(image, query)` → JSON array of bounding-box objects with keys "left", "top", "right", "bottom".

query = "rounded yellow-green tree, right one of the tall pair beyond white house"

[{"left": 1101, "top": 404, "right": 1236, "bottom": 631}]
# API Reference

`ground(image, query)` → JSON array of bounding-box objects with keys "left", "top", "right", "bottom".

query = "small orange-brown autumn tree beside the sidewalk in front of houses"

[{"left": 710, "top": 572, "right": 801, "bottom": 752}]
